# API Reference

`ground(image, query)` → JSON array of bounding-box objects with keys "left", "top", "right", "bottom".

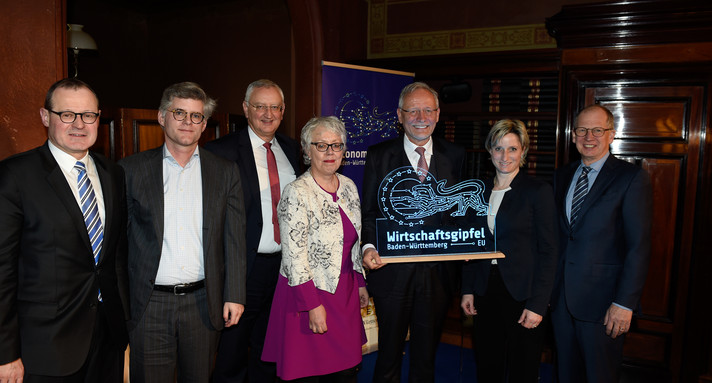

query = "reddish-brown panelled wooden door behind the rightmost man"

[{"left": 559, "top": 70, "right": 708, "bottom": 381}]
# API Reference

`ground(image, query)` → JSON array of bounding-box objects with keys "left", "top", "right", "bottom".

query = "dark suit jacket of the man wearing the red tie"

[{"left": 205, "top": 127, "right": 301, "bottom": 275}]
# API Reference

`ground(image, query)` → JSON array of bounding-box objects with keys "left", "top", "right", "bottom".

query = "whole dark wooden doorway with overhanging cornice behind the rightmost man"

[{"left": 547, "top": 0, "right": 712, "bottom": 382}]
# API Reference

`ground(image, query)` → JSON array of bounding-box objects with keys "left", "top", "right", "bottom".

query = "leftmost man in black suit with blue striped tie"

[{"left": 0, "top": 78, "right": 128, "bottom": 382}]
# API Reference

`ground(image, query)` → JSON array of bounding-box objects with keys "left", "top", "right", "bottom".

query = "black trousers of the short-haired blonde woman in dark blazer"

[{"left": 472, "top": 265, "right": 545, "bottom": 383}]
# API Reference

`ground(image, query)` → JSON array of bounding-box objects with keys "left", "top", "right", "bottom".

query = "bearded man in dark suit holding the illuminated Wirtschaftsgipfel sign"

[{"left": 361, "top": 82, "right": 465, "bottom": 382}]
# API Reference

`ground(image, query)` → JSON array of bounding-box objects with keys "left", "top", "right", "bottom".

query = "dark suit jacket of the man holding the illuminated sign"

[{"left": 361, "top": 136, "right": 465, "bottom": 295}]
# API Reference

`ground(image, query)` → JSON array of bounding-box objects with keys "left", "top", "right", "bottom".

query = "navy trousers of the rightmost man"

[{"left": 551, "top": 291, "right": 625, "bottom": 383}]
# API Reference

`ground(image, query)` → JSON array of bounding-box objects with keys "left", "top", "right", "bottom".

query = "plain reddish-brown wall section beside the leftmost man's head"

[{"left": 0, "top": 0, "right": 67, "bottom": 159}]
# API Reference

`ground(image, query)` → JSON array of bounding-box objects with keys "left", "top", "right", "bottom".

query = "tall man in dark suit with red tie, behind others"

[{"left": 205, "top": 79, "right": 300, "bottom": 383}]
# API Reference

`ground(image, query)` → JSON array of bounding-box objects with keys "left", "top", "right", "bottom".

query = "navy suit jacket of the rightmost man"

[{"left": 552, "top": 155, "right": 652, "bottom": 323}]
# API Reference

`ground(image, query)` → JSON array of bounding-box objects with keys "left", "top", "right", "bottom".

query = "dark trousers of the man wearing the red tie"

[{"left": 213, "top": 255, "right": 281, "bottom": 383}]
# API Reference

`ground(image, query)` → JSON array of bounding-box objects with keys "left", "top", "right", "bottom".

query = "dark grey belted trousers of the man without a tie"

[{"left": 129, "top": 288, "right": 219, "bottom": 383}]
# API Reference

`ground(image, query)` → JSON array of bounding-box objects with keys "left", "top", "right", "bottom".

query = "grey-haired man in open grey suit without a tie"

[{"left": 120, "top": 82, "right": 245, "bottom": 382}]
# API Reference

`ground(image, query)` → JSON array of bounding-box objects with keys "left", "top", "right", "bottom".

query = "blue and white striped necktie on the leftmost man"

[{"left": 74, "top": 161, "right": 104, "bottom": 301}]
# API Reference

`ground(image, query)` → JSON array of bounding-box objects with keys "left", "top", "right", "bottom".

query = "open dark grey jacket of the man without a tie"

[{"left": 119, "top": 146, "right": 246, "bottom": 330}]
